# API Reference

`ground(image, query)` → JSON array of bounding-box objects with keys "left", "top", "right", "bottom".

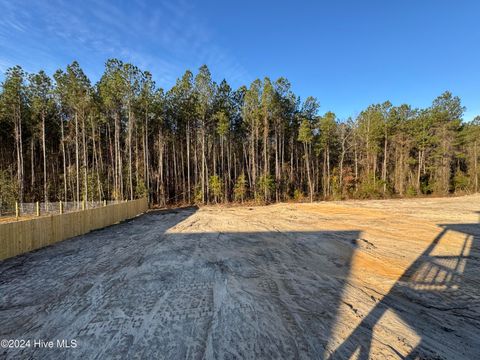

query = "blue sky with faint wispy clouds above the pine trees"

[{"left": 0, "top": 0, "right": 480, "bottom": 120}]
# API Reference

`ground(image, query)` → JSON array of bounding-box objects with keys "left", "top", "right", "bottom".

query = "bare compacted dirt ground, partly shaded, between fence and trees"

[{"left": 0, "top": 195, "right": 480, "bottom": 359}]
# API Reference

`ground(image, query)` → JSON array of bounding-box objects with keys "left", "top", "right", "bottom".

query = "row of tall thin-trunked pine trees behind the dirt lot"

[{"left": 0, "top": 59, "right": 480, "bottom": 206}]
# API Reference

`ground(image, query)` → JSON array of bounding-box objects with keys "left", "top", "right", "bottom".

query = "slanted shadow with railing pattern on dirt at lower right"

[{"left": 329, "top": 212, "right": 480, "bottom": 360}]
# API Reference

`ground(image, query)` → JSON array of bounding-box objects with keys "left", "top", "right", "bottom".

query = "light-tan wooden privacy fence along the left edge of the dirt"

[{"left": 0, "top": 199, "right": 148, "bottom": 260}]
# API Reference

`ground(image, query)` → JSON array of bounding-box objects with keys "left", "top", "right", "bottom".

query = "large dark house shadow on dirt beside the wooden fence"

[{"left": 0, "top": 208, "right": 360, "bottom": 359}]
